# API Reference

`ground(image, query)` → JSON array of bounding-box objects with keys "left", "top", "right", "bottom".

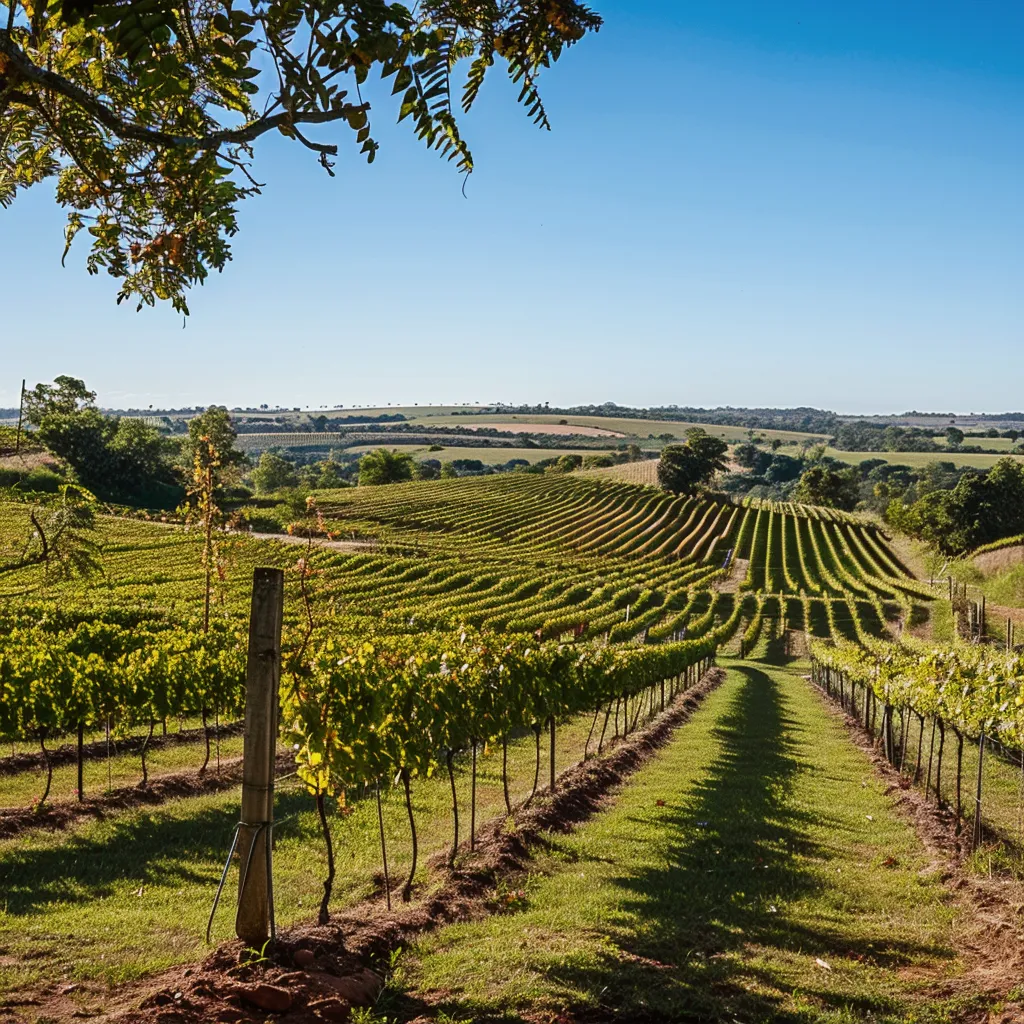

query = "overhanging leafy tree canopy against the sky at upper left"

[{"left": 0, "top": 0, "right": 601, "bottom": 313}]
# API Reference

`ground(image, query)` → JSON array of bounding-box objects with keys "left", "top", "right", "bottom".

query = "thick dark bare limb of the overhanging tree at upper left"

[{"left": 0, "top": 30, "right": 370, "bottom": 156}]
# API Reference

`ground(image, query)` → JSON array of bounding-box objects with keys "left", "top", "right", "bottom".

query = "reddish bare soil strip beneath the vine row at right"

[{"left": 815, "top": 675, "right": 1024, "bottom": 1024}]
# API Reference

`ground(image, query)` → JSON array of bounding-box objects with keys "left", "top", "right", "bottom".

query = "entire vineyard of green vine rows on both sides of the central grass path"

[{"left": 0, "top": 473, "right": 1024, "bottom": 1024}]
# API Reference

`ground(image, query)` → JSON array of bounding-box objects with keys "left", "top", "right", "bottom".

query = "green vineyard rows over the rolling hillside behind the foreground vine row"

[{"left": 0, "top": 475, "right": 929, "bottom": 770}]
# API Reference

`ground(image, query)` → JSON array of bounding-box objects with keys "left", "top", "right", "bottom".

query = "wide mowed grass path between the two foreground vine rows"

[{"left": 391, "top": 662, "right": 974, "bottom": 1024}]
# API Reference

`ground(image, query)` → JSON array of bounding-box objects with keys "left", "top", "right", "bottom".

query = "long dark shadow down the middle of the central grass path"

[{"left": 392, "top": 666, "right": 954, "bottom": 1024}]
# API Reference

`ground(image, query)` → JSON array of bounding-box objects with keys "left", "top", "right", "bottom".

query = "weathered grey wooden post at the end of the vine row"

[{"left": 234, "top": 568, "right": 285, "bottom": 949}]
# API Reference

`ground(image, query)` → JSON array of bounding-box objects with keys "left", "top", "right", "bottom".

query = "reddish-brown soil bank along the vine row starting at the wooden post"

[{"left": 6, "top": 669, "right": 725, "bottom": 1024}]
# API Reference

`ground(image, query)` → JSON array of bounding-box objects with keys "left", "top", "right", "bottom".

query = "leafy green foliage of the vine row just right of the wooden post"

[{"left": 283, "top": 630, "right": 721, "bottom": 793}]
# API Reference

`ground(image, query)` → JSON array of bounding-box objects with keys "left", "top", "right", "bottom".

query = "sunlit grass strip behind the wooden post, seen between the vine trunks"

[{"left": 0, "top": 716, "right": 598, "bottom": 992}]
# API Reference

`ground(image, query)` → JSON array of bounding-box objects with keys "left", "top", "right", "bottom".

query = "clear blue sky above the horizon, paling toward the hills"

[{"left": 0, "top": 0, "right": 1024, "bottom": 412}]
